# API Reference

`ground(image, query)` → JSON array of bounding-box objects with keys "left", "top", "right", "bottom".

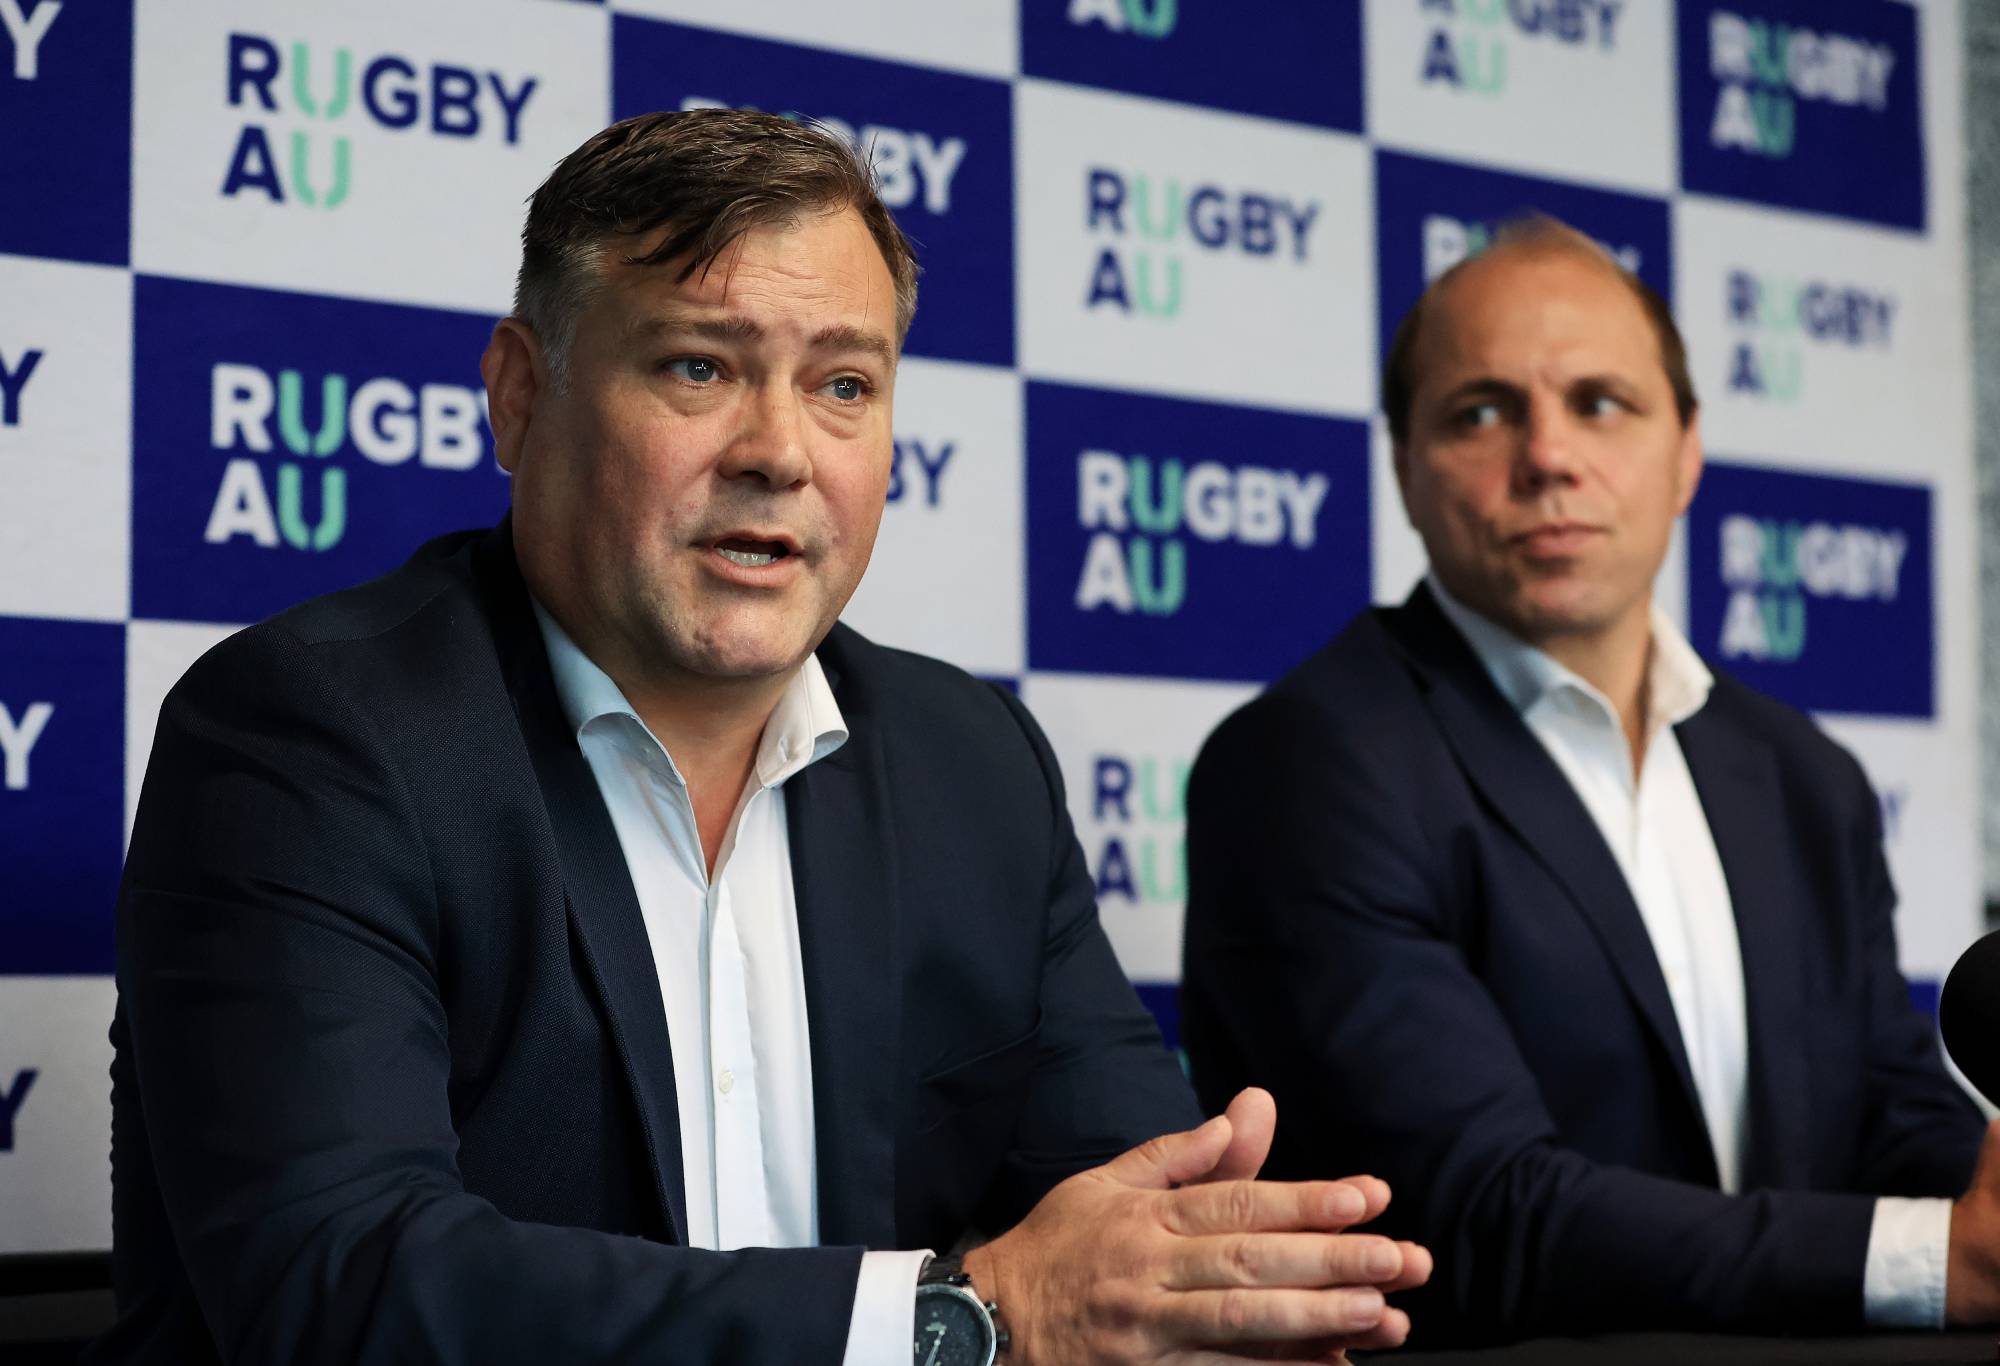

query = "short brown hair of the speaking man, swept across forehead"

[{"left": 514, "top": 108, "right": 918, "bottom": 390}]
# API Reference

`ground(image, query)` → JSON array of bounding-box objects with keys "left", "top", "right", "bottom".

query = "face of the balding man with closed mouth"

[{"left": 1396, "top": 246, "right": 1702, "bottom": 646}]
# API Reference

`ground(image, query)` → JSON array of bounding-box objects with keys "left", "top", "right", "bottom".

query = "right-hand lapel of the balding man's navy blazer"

[{"left": 1676, "top": 712, "right": 1812, "bottom": 1190}]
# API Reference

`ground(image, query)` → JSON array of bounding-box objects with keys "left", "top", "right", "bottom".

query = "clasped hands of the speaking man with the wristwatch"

[{"left": 964, "top": 1090, "right": 1430, "bottom": 1366}]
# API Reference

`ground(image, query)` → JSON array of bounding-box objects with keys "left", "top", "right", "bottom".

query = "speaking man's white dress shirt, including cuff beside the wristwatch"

[{"left": 534, "top": 604, "right": 928, "bottom": 1366}]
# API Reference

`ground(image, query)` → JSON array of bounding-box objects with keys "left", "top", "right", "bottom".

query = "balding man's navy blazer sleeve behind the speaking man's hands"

[{"left": 1182, "top": 696, "right": 1874, "bottom": 1340}]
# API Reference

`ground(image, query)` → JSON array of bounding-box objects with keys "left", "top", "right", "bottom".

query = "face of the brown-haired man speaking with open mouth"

[{"left": 502, "top": 210, "right": 896, "bottom": 690}]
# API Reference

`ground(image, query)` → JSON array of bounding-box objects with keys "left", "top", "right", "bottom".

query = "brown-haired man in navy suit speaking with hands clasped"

[{"left": 94, "top": 110, "right": 1428, "bottom": 1366}]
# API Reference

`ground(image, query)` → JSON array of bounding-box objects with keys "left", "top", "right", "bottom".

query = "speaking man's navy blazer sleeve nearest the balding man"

[{"left": 980, "top": 688, "right": 1202, "bottom": 1232}]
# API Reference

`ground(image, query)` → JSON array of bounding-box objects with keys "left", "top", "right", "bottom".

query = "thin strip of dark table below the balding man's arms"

[{"left": 1356, "top": 1330, "right": 2000, "bottom": 1366}]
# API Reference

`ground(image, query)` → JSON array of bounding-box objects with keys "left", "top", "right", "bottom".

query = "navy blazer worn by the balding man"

[{"left": 1182, "top": 588, "right": 1984, "bottom": 1342}]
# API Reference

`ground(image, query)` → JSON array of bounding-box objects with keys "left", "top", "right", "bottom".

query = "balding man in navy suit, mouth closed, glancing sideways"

[{"left": 1182, "top": 220, "right": 2000, "bottom": 1342}]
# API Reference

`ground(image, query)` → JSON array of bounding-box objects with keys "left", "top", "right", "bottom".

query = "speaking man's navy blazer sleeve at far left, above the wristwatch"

[{"left": 118, "top": 626, "right": 862, "bottom": 1366}]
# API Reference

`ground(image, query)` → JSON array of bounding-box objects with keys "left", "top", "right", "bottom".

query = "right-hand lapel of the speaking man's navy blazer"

[{"left": 784, "top": 652, "right": 902, "bottom": 1248}]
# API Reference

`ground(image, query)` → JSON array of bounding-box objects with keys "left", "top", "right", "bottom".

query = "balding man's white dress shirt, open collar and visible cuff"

[{"left": 1426, "top": 574, "right": 1952, "bottom": 1328}]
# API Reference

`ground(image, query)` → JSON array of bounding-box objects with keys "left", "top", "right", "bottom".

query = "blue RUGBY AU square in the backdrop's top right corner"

[{"left": 1678, "top": 0, "right": 1926, "bottom": 232}]
